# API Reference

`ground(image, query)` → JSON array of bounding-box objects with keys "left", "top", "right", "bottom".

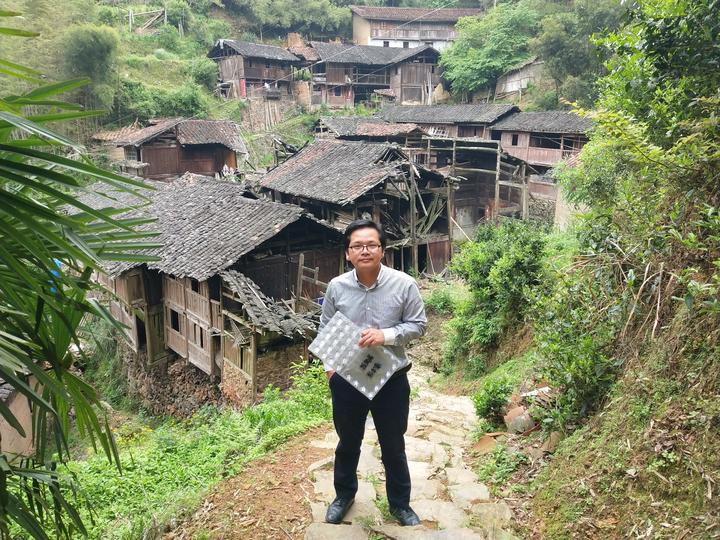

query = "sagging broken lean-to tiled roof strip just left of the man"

[{"left": 220, "top": 270, "right": 315, "bottom": 338}]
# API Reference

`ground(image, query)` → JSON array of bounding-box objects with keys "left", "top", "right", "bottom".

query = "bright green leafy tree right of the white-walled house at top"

[{"left": 440, "top": 0, "right": 539, "bottom": 95}]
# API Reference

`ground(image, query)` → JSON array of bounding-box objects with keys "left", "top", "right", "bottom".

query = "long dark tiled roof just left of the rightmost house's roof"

[{"left": 381, "top": 103, "right": 518, "bottom": 124}]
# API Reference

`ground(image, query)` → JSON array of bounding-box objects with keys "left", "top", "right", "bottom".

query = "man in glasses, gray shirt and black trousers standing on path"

[{"left": 320, "top": 219, "right": 427, "bottom": 525}]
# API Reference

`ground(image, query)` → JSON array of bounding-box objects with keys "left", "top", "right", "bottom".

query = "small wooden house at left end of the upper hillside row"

[{"left": 207, "top": 39, "right": 300, "bottom": 99}]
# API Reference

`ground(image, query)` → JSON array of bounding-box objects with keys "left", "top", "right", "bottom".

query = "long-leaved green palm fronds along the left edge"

[{"left": 0, "top": 10, "right": 156, "bottom": 539}]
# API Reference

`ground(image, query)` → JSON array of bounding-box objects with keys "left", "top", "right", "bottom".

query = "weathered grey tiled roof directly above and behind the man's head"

[{"left": 260, "top": 139, "right": 403, "bottom": 205}]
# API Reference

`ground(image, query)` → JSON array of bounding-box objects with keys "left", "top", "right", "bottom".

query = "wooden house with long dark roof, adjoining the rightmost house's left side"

[{"left": 380, "top": 103, "right": 518, "bottom": 139}]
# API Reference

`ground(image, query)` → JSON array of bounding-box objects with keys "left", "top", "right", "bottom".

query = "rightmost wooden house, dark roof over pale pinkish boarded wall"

[{"left": 490, "top": 111, "right": 592, "bottom": 172}]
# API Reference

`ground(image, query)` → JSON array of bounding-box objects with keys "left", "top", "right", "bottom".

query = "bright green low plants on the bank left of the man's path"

[{"left": 69, "top": 364, "right": 331, "bottom": 539}]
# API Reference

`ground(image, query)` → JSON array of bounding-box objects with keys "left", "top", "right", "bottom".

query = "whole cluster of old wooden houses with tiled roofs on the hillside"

[{"left": 83, "top": 7, "right": 591, "bottom": 404}]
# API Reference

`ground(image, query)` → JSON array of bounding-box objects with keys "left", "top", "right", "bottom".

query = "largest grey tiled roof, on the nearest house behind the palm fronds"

[{"left": 80, "top": 175, "right": 330, "bottom": 280}]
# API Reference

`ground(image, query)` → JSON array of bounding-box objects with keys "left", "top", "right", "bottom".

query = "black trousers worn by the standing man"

[{"left": 330, "top": 373, "right": 410, "bottom": 508}]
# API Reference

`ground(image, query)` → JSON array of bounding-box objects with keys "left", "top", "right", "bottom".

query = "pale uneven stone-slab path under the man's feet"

[{"left": 305, "top": 364, "right": 515, "bottom": 540}]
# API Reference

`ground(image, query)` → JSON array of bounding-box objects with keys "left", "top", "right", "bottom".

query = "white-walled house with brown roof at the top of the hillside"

[{"left": 350, "top": 6, "right": 482, "bottom": 50}]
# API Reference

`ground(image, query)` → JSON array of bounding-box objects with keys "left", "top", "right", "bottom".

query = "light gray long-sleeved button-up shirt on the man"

[{"left": 318, "top": 265, "right": 427, "bottom": 371}]
